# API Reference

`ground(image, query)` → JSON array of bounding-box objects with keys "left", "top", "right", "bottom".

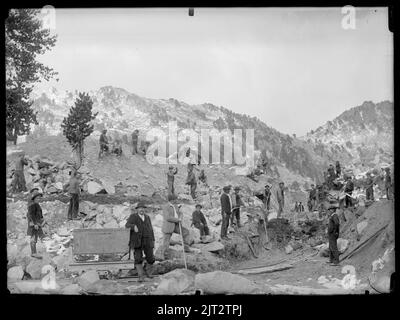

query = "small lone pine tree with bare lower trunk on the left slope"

[{"left": 61, "top": 93, "right": 97, "bottom": 169}]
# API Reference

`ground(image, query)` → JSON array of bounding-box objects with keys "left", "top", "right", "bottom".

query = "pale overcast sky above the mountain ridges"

[{"left": 36, "top": 7, "right": 393, "bottom": 136}]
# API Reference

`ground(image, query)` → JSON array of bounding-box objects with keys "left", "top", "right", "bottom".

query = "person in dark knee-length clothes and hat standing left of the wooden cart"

[{"left": 26, "top": 189, "right": 45, "bottom": 259}]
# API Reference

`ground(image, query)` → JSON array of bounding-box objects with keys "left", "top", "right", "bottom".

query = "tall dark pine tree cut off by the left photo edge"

[{"left": 5, "top": 9, "right": 57, "bottom": 144}]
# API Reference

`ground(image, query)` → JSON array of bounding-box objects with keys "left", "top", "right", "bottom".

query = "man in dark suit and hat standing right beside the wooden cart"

[{"left": 125, "top": 202, "right": 155, "bottom": 282}]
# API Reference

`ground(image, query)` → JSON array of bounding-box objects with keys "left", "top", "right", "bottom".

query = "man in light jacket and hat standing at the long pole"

[{"left": 157, "top": 197, "right": 192, "bottom": 260}]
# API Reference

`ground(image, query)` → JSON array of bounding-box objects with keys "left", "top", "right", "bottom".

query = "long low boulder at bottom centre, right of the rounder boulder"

[{"left": 195, "top": 271, "right": 257, "bottom": 294}]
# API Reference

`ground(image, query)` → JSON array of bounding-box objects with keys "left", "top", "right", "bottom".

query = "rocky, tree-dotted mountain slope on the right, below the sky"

[{"left": 301, "top": 101, "right": 394, "bottom": 168}]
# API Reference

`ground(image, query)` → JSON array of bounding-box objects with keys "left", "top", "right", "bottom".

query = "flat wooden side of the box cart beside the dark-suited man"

[{"left": 73, "top": 228, "right": 130, "bottom": 254}]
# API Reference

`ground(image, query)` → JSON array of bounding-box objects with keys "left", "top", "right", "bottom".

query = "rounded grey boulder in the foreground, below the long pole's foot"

[{"left": 154, "top": 269, "right": 195, "bottom": 295}]
